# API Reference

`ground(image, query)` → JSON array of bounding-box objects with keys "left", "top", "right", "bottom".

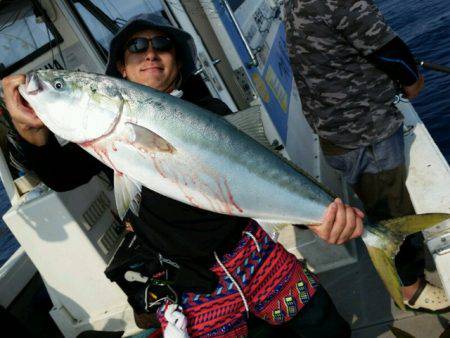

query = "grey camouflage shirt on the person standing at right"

[{"left": 285, "top": 0, "right": 403, "bottom": 148}]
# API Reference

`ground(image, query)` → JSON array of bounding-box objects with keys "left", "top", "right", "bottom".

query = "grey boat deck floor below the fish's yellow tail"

[{"left": 319, "top": 240, "right": 450, "bottom": 338}]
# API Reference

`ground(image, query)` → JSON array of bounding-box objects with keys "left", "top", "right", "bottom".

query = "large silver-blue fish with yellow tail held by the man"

[{"left": 19, "top": 70, "right": 450, "bottom": 308}]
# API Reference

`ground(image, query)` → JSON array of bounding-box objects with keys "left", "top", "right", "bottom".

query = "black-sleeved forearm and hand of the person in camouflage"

[{"left": 367, "top": 37, "right": 424, "bottom": 98}]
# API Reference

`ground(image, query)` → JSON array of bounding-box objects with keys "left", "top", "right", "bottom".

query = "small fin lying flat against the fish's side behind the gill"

[{"left": 126, "top": 122, "right": 175, "bottom": 153}]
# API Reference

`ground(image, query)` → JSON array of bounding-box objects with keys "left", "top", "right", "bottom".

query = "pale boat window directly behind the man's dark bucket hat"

[{"left": 71, "top": 0, "right": 164, "bottom": 58}]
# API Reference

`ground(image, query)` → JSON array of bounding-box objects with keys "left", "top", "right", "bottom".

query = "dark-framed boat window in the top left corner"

[{"left": 0, "top": 0, "right": 62, "bottom": 77}]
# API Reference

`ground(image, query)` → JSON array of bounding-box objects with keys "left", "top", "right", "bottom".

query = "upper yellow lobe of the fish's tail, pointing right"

[{"left": 378, "top": 213, "right": 450, "bottom": 235}]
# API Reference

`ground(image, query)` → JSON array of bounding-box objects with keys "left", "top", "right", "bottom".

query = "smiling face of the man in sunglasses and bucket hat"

[{"left": 118, "top": 29, "right": 180, "bottom": 93}]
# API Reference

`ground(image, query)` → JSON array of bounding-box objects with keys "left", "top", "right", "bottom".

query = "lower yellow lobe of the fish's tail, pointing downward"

[{"left": 367, "top": 245, "right": 405, "bottom": 310}]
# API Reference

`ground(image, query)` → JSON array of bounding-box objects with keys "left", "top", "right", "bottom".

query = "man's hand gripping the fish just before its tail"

[{"left": 308, "top": 198, "right": 364, "bottom": 244}]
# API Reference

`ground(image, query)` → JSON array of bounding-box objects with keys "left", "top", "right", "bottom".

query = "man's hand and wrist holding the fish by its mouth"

[{"left": 2, "top": 74, "right": 49, "bottom": 146}]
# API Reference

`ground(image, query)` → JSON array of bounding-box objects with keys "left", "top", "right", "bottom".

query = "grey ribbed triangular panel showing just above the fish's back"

[{"left": 224, "top": 106, "right": 270, "bottom": 148}]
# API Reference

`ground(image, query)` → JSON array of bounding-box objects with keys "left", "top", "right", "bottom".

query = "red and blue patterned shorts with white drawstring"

[{"left": 158, "top": 221, "right": 318, "bottom": 337}]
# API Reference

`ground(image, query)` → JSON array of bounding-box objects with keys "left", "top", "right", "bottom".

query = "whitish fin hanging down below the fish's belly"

[{"left": 114, "top": 172, "right": 142, "bottom": 220}]
